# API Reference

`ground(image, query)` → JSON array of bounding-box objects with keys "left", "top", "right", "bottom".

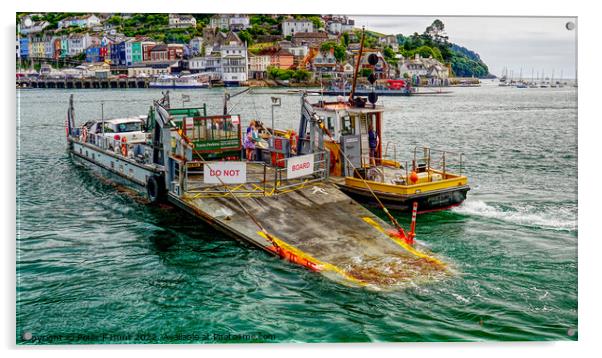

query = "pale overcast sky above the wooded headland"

[{"left": 350, "top": 16, "right": 577, "bottom": 78}]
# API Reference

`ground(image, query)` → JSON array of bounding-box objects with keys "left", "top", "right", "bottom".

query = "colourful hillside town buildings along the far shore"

[{"left": 16, "top": 13, "right": 460, "bottom": 86}]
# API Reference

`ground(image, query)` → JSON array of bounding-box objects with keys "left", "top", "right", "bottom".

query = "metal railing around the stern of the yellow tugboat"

[{"left": 412, "top": 146, "right": 464, "bottom": 178}]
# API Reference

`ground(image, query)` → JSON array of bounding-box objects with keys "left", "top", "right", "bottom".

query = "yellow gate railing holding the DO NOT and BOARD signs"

[{"left": 183, "top": 151, "right": 330, "bottom": 197}]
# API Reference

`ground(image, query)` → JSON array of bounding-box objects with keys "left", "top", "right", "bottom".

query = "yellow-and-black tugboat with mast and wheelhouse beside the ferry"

[{"left": 299, "top": 28, "right": 470, "bottom": 213}]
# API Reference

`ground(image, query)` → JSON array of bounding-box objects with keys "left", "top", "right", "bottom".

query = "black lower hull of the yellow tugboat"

[{"left": 338, "top": 184, "right": 470, "bottom": 214}]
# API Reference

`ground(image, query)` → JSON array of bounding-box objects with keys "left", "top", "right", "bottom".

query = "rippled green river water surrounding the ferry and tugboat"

[{"left": 16, "top": 86, "right": 578, "bottom": 343}]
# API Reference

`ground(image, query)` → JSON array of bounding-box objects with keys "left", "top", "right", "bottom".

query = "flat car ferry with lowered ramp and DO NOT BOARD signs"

[{"left": 66, "top": 96, "right": 453, "bottom": 290}]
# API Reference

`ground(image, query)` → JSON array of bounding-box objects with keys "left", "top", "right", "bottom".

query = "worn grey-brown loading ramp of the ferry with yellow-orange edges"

[{"left": 170, "top": 161, "right": 449, "bottom": 290}]
